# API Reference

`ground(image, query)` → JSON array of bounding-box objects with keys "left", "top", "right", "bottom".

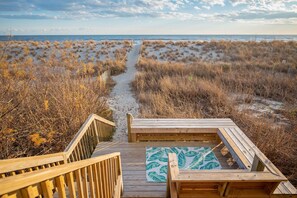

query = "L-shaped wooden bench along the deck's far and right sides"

[{"left": 127, "top": 114, "right": 297, "bottom": 197}]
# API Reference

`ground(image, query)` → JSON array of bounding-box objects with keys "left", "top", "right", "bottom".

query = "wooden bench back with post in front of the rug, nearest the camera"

[{"left": 167, "top": 153, "right": 287, "bottom": 198}]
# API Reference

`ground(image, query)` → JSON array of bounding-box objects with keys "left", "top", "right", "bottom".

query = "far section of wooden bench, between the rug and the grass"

[{"left": 127, "top": 114, "right": 236, "bottom": 142}]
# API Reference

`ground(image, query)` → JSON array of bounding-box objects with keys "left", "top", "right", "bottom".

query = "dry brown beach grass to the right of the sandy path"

[{"left": 133, "top": 41, "right": 297, "bottom": 185}]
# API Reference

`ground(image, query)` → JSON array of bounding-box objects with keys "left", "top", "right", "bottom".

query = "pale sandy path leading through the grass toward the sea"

[{"left": 108, "top": 44, "right": 141, "bottom": 141}]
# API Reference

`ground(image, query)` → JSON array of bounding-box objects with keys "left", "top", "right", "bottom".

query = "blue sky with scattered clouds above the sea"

[{"left": 0, "top": 0, "right": 297, "bottom": 35}]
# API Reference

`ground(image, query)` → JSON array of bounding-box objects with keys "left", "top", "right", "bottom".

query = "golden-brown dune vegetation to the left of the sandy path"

[{"left": 0, "top": 41, "right": 131, "bottom": 159}]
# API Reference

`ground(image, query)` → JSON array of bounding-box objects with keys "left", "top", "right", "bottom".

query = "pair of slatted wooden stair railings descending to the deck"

[{"left": 0, "top": 114, "right": 123, "bottom": 198}]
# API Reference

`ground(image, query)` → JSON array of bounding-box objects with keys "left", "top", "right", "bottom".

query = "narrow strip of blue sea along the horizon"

[{"left": 0, "top": 35, "right": 297, "bottom": 41}]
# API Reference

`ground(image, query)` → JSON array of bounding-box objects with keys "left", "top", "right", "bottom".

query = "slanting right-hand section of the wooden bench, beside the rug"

[{"left": 218, "top": 126, "right": 297, "bottom": 197}]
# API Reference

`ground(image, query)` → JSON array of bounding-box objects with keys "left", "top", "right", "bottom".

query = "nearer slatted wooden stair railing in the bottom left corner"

[{"left": 0, "top": 153, "right": 123, "bottom": 198}]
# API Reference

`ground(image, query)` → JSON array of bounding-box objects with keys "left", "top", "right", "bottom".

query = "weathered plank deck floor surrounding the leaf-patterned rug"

[{"left": 92, "top": 142, "right": 238, "bottom": 197}]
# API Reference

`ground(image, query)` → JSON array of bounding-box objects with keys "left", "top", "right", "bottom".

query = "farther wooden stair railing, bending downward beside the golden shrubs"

[{"left": 0, "top": 114, "right": 115, "bottom": 178}]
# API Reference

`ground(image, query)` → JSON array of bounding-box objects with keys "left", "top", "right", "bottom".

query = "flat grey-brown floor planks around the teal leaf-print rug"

[{"left": 93, "top": 141, "right": 240, "bottom": 197}]
